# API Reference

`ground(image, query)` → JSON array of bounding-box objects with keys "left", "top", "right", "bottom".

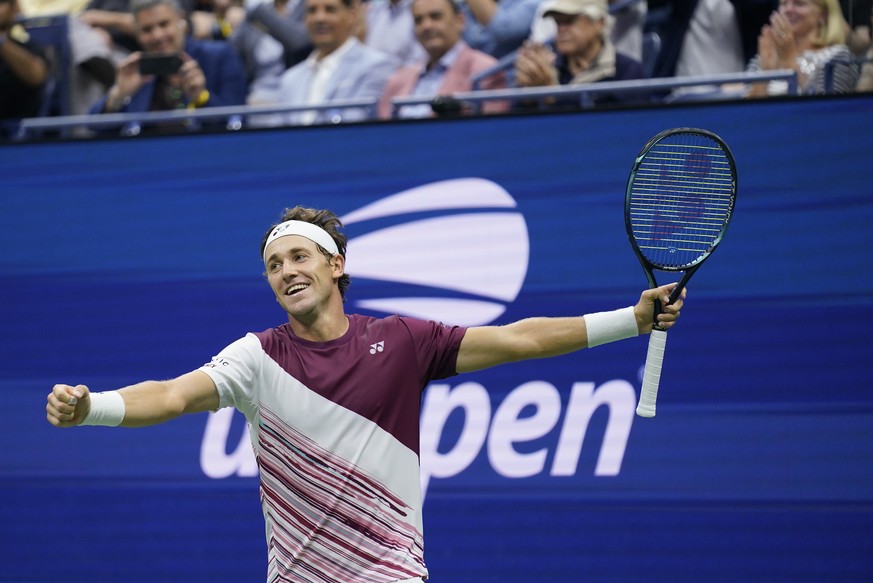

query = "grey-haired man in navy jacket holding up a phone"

[{"left": 91, "top": 0, "right": 246, "bottom": 113}]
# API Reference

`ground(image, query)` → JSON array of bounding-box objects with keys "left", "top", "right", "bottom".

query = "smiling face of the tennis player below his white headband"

[{"left": 264, "top": 235, "right": 344, "bottom": 321}]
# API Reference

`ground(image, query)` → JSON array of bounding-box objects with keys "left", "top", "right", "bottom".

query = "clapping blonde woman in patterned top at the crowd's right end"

[{"left": 748, "top": 0, "right": 858, "bottom": 97}]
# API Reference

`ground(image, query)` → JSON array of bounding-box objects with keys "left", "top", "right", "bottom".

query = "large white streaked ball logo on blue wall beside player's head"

[{"left": 342, "top": 178, "right": 530, "bottom": 326}]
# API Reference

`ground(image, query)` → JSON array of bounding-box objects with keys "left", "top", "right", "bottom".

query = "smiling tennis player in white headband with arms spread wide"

[{"left": 46, "top": 207, "right": 684, "bottom": 583}]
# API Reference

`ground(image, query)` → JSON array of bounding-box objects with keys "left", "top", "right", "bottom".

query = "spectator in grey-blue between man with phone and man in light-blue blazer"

[{"left": 229, "top": 0, "right": 312, "bottom": 105}]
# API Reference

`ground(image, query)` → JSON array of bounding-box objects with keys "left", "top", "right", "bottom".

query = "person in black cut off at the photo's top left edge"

[{"left": 0, "top": 0, "right": 48, "bottom": 128}]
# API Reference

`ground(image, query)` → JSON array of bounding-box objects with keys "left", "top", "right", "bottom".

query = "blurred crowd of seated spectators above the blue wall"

[{"left": 0, "top": 0, "right": 873, "bottom": 136}]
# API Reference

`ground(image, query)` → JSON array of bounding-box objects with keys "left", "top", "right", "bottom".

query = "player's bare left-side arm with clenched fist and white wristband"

[{"left": 46, "top": 370, "right": 219, "bottom": 427}]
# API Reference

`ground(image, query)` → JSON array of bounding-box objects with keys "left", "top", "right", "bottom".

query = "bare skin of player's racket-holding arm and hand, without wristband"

[{"left": 456, "top": 284, "right": 685, "bottom": 373}]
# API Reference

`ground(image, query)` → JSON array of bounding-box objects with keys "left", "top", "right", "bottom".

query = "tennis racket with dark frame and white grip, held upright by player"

[{"left": 624, "top": 128, "right": 737, "bottom": 417}]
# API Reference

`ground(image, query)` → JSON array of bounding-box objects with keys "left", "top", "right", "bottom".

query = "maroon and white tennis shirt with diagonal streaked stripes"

[{"left": 200, "top": 315, "right": 466, "bottom": 583}]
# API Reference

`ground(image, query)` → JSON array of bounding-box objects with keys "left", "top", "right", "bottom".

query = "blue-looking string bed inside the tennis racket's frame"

[{"left": 629, "top": 135, "right": 735, "bottom": 269}]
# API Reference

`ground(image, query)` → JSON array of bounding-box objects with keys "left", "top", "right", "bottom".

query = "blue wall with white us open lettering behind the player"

[{"left": 0, "top": 96, "right": 873, "bottom": 583}]
